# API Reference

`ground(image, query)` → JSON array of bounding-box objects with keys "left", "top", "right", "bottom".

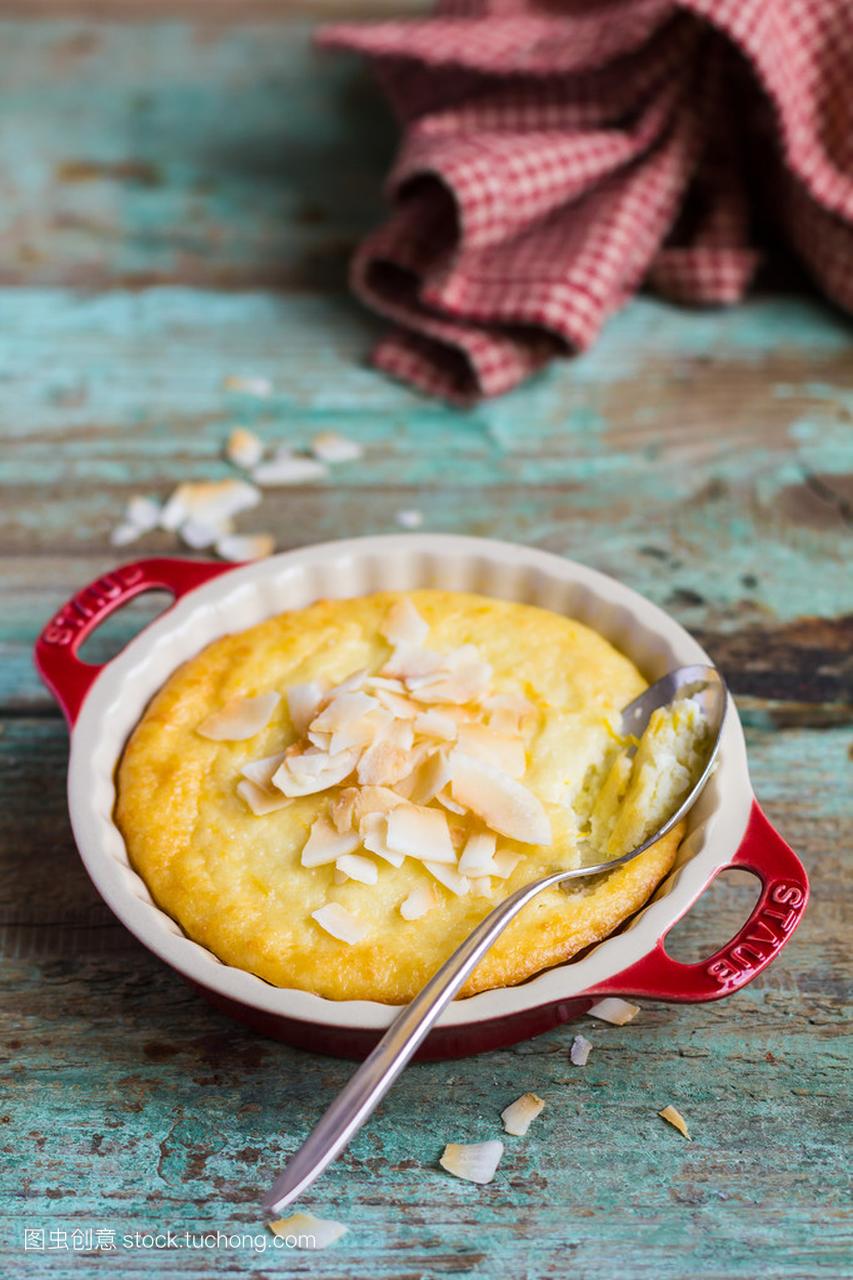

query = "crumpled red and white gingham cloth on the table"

[{"left": 319, "top": 0, "right": 853, "bottom": 403}]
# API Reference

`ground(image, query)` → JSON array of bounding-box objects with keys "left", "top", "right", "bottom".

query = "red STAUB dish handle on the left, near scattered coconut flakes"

[{"left": 35, "top": 557, "right": 237, "bottom": 727}]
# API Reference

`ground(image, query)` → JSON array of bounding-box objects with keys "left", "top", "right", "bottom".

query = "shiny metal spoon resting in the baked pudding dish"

[{"left": 264, "top": 666, "right": 726, "bottom": 1213}]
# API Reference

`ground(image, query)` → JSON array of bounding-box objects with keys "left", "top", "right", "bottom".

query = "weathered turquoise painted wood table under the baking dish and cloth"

[{"left": 0, "top": 0, "right": 853, "bottom": 1280}]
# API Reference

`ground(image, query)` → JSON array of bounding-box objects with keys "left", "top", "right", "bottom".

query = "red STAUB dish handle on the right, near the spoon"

[{"left": 584, "top": 800, "right": 808, "bottom": 1001}]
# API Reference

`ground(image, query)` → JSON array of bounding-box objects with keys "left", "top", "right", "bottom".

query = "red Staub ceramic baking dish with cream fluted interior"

[{"left": 36, "top": 535, "right": 808, "bottom": 1059}]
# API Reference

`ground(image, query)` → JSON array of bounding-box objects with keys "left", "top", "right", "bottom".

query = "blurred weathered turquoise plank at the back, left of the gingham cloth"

[{"left": 0, "top": 17, "right": 394, "bottom": 289}]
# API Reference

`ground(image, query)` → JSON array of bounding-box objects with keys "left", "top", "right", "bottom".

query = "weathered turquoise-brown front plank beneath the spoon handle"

[{"left": 0, "top": 721, "right": 848, "bottom": 1280}]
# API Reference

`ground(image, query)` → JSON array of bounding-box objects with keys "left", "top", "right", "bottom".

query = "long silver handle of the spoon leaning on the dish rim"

[{"left": 258, "top": 872, "right": 566, "bottom": 1212}]
